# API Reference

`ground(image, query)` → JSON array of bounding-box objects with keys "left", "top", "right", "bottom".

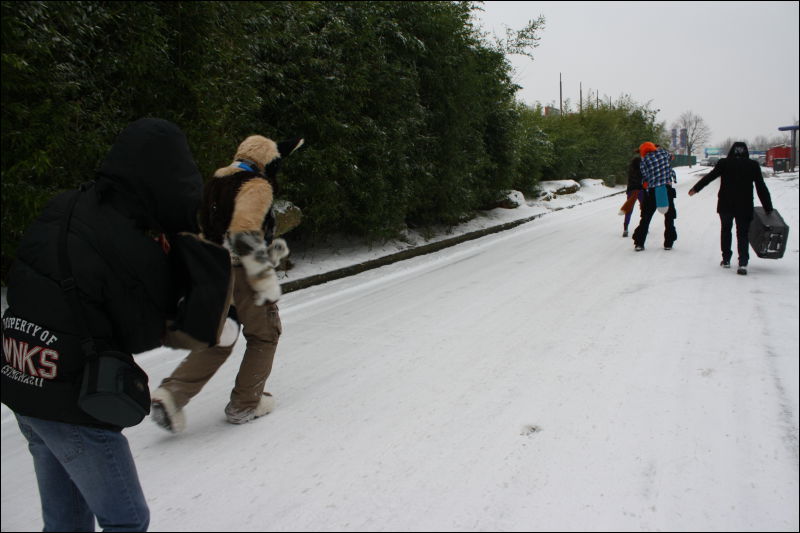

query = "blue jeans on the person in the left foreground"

[{"left": 16, "top": 414, "right": 150, "bottom": 531}]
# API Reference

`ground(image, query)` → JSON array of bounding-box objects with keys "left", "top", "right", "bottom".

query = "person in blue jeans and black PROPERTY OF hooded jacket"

[{"left": 2, "top": 118, "right": 230, "bottom": 531}]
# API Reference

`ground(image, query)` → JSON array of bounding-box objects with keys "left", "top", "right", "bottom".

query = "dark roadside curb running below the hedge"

[{"left": 281, "top": 191, "right": 625, "bottom": 294}]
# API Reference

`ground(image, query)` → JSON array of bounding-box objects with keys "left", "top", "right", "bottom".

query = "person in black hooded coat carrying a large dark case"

[{"left": 689, "top": 142, "right": 772, "bottom": 275}]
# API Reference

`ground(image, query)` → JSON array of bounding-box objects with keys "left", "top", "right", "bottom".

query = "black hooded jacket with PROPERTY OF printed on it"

[{"left": 2, "top": 119, "right": 212, "bottom": 427}]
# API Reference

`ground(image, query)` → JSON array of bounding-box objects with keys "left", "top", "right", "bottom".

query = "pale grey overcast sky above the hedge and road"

[{"left": 477, "top": 1, "right": 800, "bottom": 146}]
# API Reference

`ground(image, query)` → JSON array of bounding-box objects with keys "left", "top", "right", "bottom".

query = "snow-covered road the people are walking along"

[{"left": 0, "top": 167, "right": 800, "bottom": 531}]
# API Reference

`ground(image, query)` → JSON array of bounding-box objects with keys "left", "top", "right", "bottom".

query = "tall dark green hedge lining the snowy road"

[{"left": 1, "top": 1, "right": 657, "bottom": 281}]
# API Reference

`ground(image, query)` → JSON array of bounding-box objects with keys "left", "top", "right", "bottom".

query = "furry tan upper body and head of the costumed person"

[{"left": 209, "top": 135, "right": 303, "bottom": 305}]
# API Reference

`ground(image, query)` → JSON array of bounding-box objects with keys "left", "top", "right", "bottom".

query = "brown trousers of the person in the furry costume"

[{"left": 161, "top": 266, "right": 283, "bottom": 409}]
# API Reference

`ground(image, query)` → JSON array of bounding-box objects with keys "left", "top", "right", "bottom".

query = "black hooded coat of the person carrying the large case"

[{"left": 692, "top": 142, "right": 772, "bottom": 215}]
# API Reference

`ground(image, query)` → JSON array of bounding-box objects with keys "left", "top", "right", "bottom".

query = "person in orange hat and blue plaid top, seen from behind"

[{"left": 633, "top": 142, "right": 678, "bottom": 252}]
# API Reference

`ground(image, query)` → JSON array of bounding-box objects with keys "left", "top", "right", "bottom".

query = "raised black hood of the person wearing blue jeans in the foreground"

[{"left": 98, "top": 118, "right": 203, "bottom": 233}]
